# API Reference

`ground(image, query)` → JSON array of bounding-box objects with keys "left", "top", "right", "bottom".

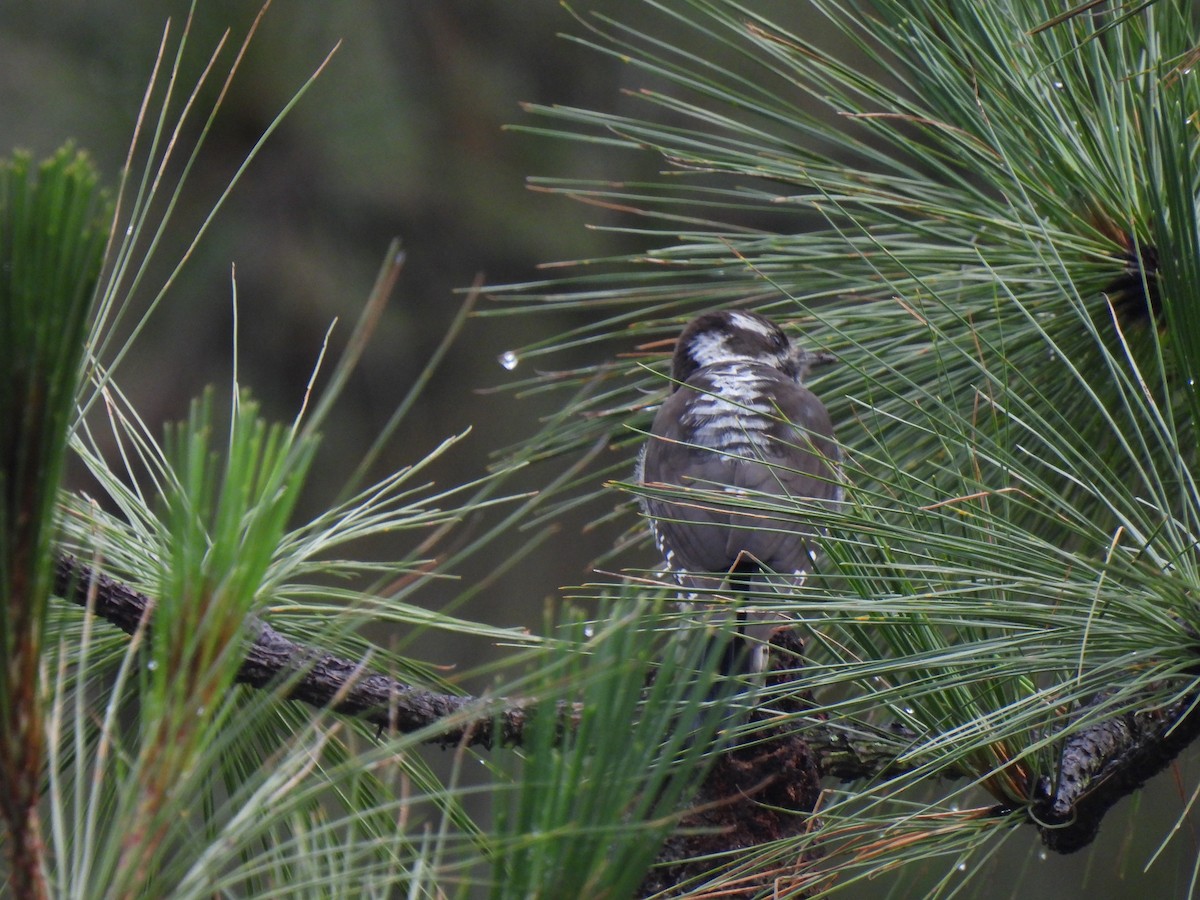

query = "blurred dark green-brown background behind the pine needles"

[{"left": 0, "top": 0, "right": 1192, "bottom": 898}]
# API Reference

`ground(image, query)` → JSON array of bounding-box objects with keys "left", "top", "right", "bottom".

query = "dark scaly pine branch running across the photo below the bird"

[{"left": 55, "top": 554, "right": 1200, "bottom": 853}]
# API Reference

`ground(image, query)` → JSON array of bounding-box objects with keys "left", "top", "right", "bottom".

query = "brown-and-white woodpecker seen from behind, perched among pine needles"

[{"left": 636, "top": 310, "right": 841, "bottom": 673}]
